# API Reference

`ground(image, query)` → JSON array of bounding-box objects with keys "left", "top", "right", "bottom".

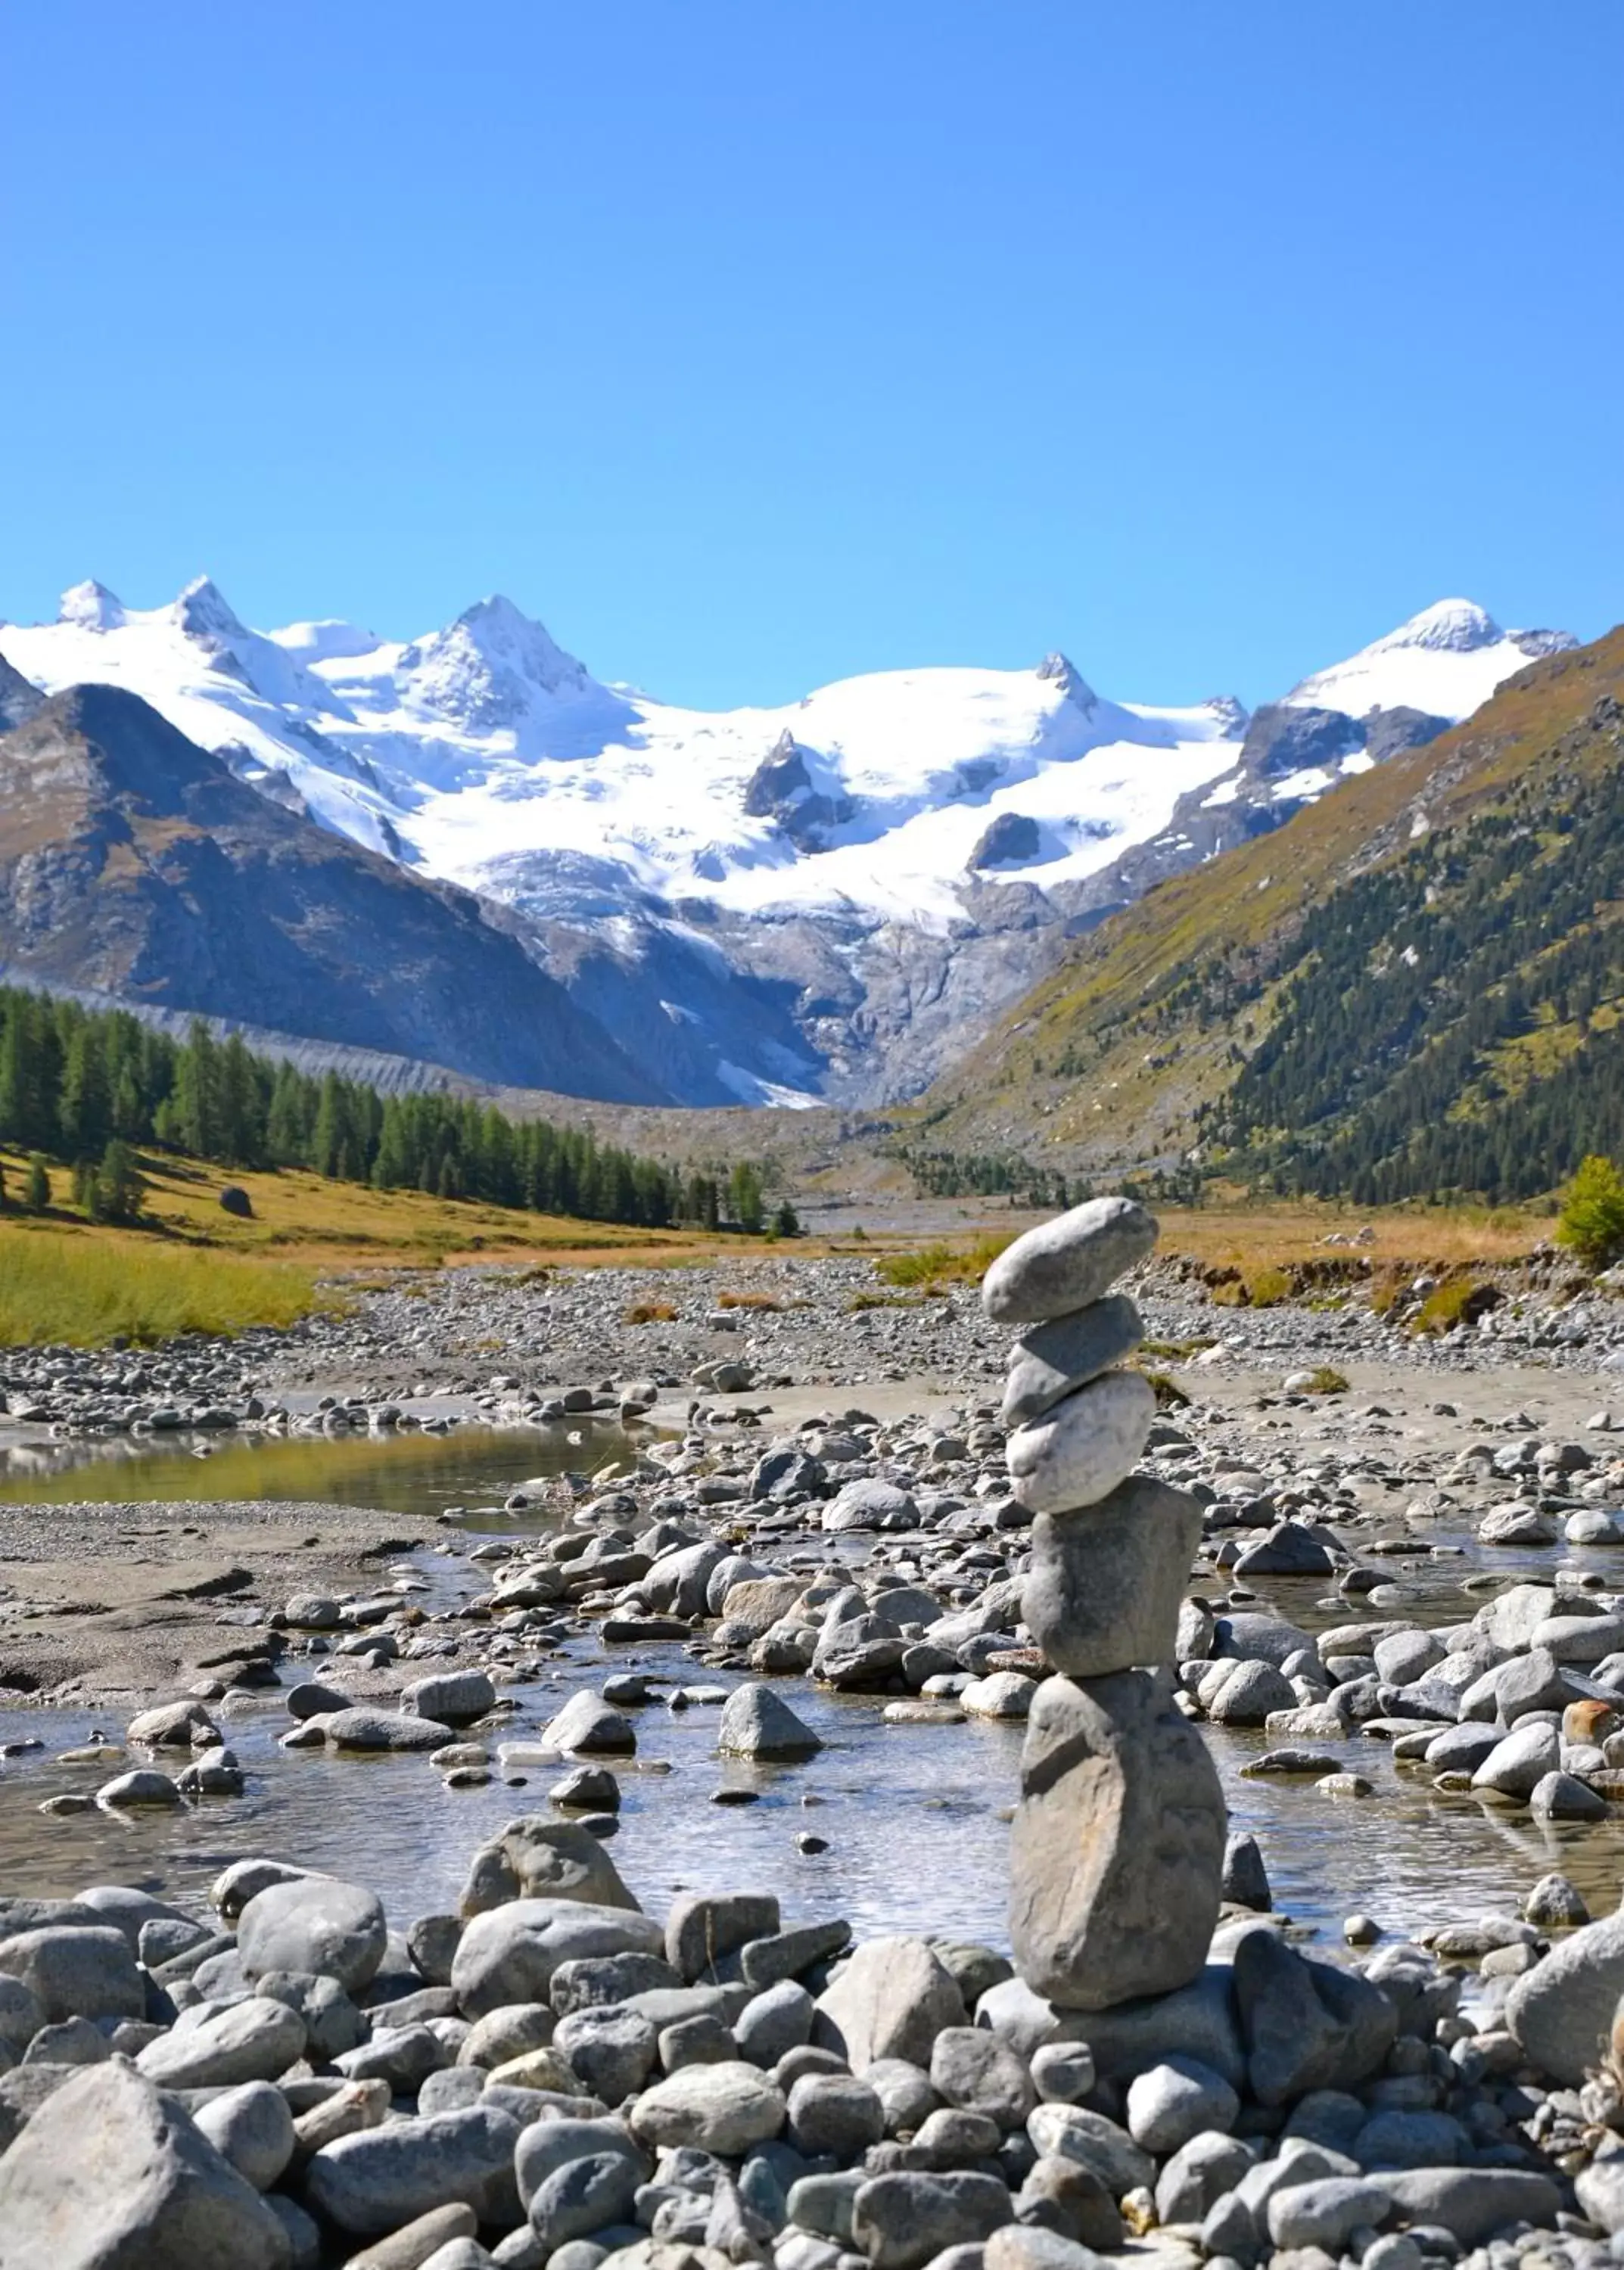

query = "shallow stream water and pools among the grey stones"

[{"left": 0, "top": 1432, "right": 1624, "bottom": 1945}]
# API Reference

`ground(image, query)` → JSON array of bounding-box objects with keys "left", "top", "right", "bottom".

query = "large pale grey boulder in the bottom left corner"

[{"left": 0, "top": 2061, "right": 293, "bottom": 2270}]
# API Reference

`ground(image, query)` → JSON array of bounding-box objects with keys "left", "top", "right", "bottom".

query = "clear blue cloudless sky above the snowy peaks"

[{"left": 0, "top": 0, "right": 1624, "bottom": 704}]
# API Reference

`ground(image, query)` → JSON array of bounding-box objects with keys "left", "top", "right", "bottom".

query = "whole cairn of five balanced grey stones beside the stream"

[{"left": 982, "top": 1199, "right": 1224, "bottom": 2011}]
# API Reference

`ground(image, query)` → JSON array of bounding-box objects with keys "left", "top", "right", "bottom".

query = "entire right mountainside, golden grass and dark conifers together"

[{"left": 904, "top": 629, "right": 1624, "bottom": 1201}]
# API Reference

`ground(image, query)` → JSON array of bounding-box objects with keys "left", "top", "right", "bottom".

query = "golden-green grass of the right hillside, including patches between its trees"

[{"left": 907, "top": 629, "right": 1624, "bottom": 1196}]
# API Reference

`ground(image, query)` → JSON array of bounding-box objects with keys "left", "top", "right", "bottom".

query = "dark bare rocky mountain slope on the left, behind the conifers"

[{"left": 0, "top": 686, "right": 667, "bottom": 1103}]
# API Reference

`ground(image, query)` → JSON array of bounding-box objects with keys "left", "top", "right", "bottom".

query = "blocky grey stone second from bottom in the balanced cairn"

[{"left": 1020, "top": 1473, "right": 1202, "bottom": 1680}]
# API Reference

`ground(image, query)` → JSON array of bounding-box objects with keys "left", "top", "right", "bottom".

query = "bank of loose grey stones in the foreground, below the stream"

[{"left": 0, "top": 1814, "right": 1624, "bottom": 2270}]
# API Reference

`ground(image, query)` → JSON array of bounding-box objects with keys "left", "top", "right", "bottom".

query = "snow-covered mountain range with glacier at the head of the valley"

[{"left": 0, "top": 579, "right": 1572, "bottom": 1103}]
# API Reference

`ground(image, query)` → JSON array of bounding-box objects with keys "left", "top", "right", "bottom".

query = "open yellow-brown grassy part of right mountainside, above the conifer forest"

[{"left": 909, "top": 629, "right": 1624, "bottom": 1194}]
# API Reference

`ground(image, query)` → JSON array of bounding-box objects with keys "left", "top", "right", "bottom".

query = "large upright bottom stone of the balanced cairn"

[{"left": 1011, "top": 1671, "right": 1227, "bottom": 2009}]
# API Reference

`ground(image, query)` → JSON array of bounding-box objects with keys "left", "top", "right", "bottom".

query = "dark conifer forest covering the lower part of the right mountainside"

[{"left": 1204, "top": 745, "right": 1624, "bottom": 1205}]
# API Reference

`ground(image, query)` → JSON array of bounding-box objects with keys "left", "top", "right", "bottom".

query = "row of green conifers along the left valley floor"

[{"left": 0, "top": 987, "right": 763, "bottom": 1230}]
